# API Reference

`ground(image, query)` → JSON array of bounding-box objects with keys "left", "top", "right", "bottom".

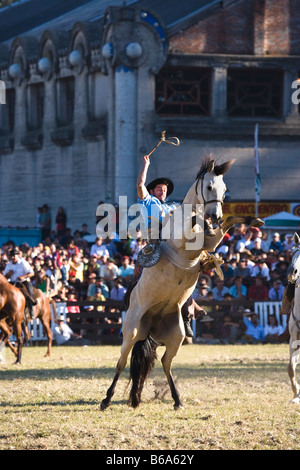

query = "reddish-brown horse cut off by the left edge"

[{"left": 0, "top": 274, "right": 26, "bottom": 364}]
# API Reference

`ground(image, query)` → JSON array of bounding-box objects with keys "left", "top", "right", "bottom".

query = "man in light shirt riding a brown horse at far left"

[{"left": 3, "top": 248, "right": 37, "bottom": 319}]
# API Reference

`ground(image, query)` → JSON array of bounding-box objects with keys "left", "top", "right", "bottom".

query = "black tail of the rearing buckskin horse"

[{"left": 129, "top": 336, "right": 159, "bottom": 408}]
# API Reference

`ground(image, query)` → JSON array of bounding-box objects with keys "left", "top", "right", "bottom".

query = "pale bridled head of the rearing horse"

[{"left": 196, "top": 157, "right": 234, "bottom": 223}]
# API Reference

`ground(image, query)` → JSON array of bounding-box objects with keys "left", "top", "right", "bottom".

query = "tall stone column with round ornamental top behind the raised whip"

[{"left": 102, "top": 6, "right": 167, "bottom": 204}]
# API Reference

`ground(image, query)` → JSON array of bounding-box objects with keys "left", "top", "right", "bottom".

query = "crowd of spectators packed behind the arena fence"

[{"left": 0, "top": 206, "right": 293, "bottom": 342}]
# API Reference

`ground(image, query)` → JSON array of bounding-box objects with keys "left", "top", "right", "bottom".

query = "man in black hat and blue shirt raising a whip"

[{"left": 137, "top": 155, "right": 205, "bottom": 337}]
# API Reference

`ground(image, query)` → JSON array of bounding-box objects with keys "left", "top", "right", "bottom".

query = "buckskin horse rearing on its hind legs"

[{"left": 101, "top": 156, "right": 263, "bottom": 410}]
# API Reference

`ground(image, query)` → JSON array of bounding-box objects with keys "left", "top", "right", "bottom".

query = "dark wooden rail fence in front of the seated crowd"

[{"left": 24, "top": 299, "right": 286, "bottom": 344}]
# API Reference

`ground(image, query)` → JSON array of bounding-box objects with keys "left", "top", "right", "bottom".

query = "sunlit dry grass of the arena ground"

[{"left": 0, "top": 345, "right": 300, "bottom": 450}]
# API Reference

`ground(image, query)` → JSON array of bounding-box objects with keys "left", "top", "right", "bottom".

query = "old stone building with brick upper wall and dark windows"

[{"left": 0, "top": 0, "right": 300, "bottom": 234}]
